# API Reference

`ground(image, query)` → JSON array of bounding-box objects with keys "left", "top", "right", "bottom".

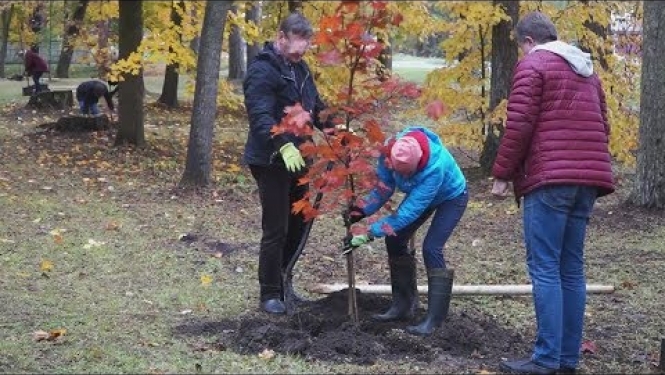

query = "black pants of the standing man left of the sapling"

[{"left": 250, "top": 163, "right": 308, "bottom": 301}]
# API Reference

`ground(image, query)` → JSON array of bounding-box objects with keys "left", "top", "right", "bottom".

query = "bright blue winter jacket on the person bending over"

[{"left": 363, "top": 127, "right": 466, "bottom": 237}]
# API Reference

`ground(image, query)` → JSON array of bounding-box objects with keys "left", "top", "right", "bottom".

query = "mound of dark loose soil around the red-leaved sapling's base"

[{"left": 210, "top": 291, "right": 530, "bottom": 368}]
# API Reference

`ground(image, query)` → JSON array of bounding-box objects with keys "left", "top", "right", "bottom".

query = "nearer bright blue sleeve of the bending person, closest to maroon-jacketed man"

[{"left": 370, "top": 171, "right": 443, "bottom": 237}]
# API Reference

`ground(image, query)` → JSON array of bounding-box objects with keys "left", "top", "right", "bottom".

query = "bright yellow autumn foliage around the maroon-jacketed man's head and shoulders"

[{"left": 422, "top": 1, "right": 641, "bottom": 164}]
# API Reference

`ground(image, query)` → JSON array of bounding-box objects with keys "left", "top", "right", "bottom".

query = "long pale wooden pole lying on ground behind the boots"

[{"left": 308, "top": 283, "right": 614, "bottom": 295}]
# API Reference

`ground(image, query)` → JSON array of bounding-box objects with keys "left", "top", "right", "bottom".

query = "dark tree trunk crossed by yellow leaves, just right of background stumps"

[{"left": 115, "top": 1, "right": 145, "bottom": 146}]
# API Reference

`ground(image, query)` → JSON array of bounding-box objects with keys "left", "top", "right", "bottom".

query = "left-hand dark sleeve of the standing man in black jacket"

[{"left": 243, "top": 61, "right": 289, "bottom": 150}]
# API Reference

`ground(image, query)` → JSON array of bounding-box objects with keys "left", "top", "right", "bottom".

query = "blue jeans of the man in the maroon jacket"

[{"left": 524, "top": 185, "right": 597, "bottom": 369}]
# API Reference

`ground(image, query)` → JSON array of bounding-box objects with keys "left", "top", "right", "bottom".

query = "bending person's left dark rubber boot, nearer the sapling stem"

[{"left": 372, "top": 255, "right": 418, "bottom": 322}]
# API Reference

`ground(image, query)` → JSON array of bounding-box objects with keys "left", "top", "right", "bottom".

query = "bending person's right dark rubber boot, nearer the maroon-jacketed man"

[{"left": 406, "top": 268, "right": 455, "bottom": 336}]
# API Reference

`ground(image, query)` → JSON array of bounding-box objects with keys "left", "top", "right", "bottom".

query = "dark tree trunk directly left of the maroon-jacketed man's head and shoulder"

[{"left": 480, "top": 0, "right": 520, "bottom": 175}]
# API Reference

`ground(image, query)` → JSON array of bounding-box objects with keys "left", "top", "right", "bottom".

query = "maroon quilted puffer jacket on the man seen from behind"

[{"left": 492, "top": 42, "right": 614, "bottom": 202}]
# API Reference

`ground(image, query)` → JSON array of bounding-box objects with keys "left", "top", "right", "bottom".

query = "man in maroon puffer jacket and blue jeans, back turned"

[{"left": 492, "top": 12, "right": 614, "bottom": 374}]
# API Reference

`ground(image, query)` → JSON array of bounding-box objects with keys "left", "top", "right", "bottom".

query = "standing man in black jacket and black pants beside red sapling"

[{"left": 243, "top": 13, "right": 331, "bottom": 314}]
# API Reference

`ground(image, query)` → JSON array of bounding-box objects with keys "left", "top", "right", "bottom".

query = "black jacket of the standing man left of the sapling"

[{"left": 243, "top": 42, "right": 329, "bottom": 166}]
